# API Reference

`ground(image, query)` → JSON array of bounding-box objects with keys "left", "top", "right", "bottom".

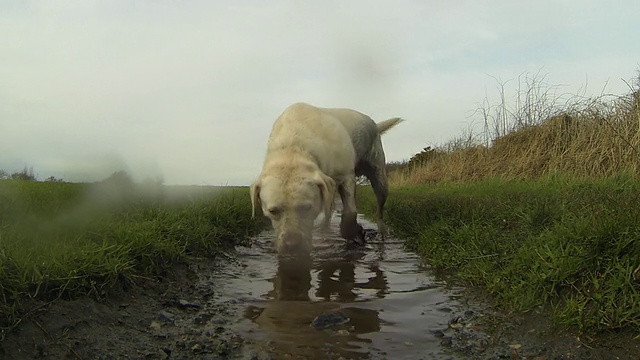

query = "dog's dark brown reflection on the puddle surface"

[{"left": 246, "top": 252, "right": 388, "bottom": 359}]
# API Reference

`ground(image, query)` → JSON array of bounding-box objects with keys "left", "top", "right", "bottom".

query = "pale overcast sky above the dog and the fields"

[{"left": 0, "top": 0, "right": 640, "bottom": 185}]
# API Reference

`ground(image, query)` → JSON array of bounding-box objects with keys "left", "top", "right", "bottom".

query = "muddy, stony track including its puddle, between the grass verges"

[{"left": 0, "top": 210, "right": 640, "bottom": 360}]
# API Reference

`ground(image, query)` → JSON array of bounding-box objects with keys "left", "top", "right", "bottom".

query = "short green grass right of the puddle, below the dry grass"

[{"left": 358, "top": 176, "right": 640, "bottom": 331}]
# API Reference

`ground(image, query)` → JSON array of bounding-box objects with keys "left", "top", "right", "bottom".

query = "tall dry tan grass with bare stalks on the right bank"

[{"left": 390, "top": 70, "right": 640, "bottom": 186}]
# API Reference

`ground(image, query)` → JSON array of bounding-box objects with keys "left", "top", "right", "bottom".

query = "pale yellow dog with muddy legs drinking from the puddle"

[{"left": 251, "top": 103, "right": 402, "bottom": 254}]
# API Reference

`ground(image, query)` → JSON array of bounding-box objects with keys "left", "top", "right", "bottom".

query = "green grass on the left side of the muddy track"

[{"left": 0, "top": 180, "right": 261, "bottom": 329}]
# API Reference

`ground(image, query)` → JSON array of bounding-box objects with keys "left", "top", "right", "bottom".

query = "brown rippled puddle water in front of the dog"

[{"left": 211, "top": 210, "right": 470, "bottom": 359}]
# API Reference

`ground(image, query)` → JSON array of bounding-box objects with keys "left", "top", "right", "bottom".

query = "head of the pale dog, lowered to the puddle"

[{"left": 251, "top": 163, "right": 336, "bottom": 255}]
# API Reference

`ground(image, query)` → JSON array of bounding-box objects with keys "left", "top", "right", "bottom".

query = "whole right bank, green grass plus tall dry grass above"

[{"left": 370, "top": 74, "right": 640, "bottom": 332}]
